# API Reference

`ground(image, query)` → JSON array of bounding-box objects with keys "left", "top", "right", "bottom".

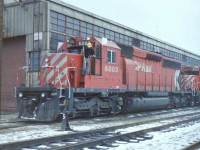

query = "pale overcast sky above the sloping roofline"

[{"left": 62, "top": 0, "right": 200, "bottom": 55}]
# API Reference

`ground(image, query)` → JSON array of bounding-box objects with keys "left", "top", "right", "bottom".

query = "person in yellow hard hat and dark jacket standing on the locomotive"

[{"left": 83, "top": 42, "right": 95, "bottom": 74}]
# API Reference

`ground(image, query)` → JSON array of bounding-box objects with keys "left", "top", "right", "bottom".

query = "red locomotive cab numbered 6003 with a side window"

[{"left": 56, "top": 37, "right": 122, "bottom": 89}]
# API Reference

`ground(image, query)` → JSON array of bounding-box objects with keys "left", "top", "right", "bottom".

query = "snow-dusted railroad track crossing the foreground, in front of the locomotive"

[{"left": 0, "top": 109, "right": 200, "bottom": 150}]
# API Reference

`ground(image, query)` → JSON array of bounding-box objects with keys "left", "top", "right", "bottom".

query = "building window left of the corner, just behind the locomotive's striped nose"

[{"left": 29, "top": 51, "right": 40, "bottom": 71}]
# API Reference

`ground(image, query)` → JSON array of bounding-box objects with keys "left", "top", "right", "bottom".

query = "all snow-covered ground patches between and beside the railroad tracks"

[{"left": 0, "top": 110, "right": 200, "bottom": 150}]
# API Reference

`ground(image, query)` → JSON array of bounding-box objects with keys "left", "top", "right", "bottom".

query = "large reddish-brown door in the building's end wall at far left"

[{"left": 0, "top": 36, "right": 26, "bottom": 110}]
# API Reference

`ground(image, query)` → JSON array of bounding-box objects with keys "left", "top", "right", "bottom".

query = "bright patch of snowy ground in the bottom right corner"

[{"left": 103, "top": 120, "right": 200, "bottom": 150}]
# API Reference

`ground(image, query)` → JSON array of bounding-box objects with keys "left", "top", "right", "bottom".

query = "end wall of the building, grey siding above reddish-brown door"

[{"left": 1, "top": 0, "right": 47, "bottom": 110}]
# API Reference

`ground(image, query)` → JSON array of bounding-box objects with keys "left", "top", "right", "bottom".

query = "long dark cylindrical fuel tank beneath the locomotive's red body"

[{"left": 125, "top": 97, "right": 169, "bottom": 112}]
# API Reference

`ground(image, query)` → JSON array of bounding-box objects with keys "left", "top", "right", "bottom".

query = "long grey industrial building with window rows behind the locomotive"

[{"left": 1, "top": 0, "right": 200, "bottom": 110}]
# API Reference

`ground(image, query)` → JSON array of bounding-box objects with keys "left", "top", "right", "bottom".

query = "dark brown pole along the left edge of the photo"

[{"left": 0, "top": 0, "right": 4, "bottom": 113}]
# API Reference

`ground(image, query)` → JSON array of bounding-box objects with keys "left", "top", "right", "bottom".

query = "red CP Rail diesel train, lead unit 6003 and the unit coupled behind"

[{"left": 17, "top": 37, "right": 200, "bottom": 121}]
